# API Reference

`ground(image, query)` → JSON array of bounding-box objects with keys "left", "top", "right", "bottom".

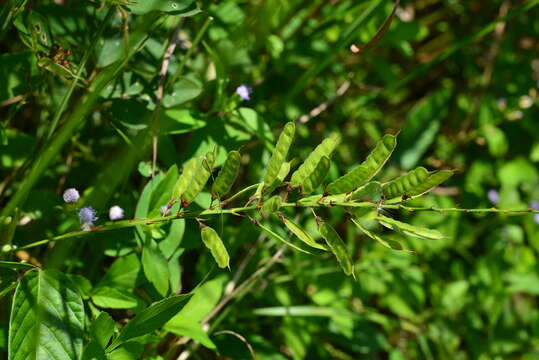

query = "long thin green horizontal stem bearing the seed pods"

[{"left": 13, "top": 200, "right": 539, "bottom": 250}]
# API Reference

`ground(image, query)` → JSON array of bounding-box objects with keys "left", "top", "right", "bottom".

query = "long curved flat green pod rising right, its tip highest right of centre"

[{"left": 327, "top": 135, "right": 397, "bottom": 194}]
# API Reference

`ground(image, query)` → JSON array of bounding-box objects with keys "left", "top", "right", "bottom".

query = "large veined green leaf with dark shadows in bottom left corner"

[{"left": 8, "top": 270, "right": 84, "bottom": 360}]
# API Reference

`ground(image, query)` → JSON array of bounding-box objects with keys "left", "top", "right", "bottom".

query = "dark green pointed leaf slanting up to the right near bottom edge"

[{"left": 108, "top": 294, "right": 193, "bottom": 351}]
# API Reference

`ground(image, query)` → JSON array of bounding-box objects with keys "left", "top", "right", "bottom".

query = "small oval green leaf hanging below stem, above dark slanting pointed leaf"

[{"left": 142, "top": 236, "right": 170, "bottom": 296}]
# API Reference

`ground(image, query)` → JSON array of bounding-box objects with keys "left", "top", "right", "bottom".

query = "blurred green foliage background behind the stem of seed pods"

[{"left": 0, "top": 0, "right": 539, "bottom": 360}]
